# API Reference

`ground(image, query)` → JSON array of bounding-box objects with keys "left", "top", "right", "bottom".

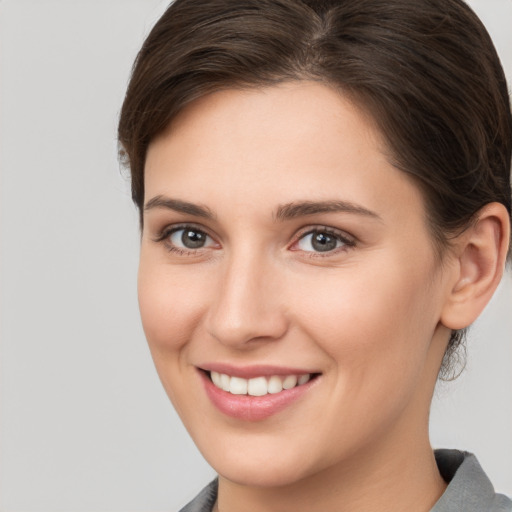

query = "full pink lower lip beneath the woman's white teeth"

[{"left": 200, "top": 371, "right": 318, "bottom": 421}]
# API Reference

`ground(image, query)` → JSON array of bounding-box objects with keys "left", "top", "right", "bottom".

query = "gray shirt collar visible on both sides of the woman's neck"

[{"left": 180, "top": 450, "right": 512, "bottom": 512}]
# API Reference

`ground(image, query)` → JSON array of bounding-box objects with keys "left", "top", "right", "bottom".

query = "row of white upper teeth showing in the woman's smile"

[{"left": 210, "top": 372, "right": 311, "bottom": 396}]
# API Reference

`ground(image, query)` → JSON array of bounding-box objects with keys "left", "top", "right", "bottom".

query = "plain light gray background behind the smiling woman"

[{"left": 0, "top": 0, "right": 512, "bottom": 512}]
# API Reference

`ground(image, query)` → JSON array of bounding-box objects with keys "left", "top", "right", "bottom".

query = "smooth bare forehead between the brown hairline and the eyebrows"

[{"left": 145, "top": 82, "right": 422, "bottom": 223}]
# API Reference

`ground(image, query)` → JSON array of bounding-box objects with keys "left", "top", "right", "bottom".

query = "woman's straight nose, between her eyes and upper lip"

[{"left": 206, "top": 251, "right": 288, "bottom": 349}]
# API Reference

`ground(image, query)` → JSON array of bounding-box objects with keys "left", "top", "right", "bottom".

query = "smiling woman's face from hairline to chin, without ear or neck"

[{"left": 139, "top": 82, "right": 449, "bottom": 486}]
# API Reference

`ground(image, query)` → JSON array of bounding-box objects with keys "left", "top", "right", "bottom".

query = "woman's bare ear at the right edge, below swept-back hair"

[{"left": 441, "top": 203, "right": 510, "bottom": 329}]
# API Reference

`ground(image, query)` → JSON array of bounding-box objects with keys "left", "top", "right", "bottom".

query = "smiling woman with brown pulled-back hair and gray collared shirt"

[{"left": 119, "top": 0, "right": 512, "bottom": 512}]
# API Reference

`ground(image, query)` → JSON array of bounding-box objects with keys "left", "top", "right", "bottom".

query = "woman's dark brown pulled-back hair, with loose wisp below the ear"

[{"left": 119, "top": 0, "right": 512, "bottom": 376}]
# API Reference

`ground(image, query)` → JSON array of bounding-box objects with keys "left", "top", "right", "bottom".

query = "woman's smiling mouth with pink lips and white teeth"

[{"left": 199, "top": 366, "right": 321, "bottom": 422}]
